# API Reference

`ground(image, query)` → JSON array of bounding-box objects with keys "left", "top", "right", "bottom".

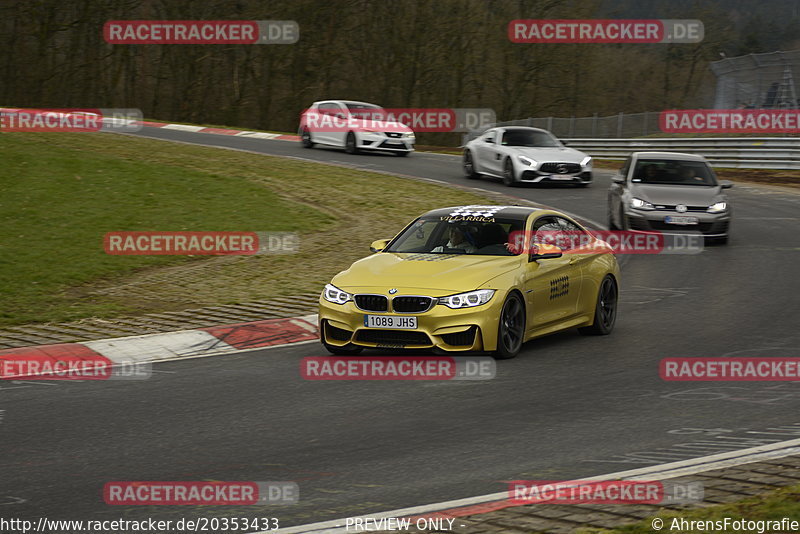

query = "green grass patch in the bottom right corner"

[{"left": 576, "top": 485, "right": 800, "bottom": 534}]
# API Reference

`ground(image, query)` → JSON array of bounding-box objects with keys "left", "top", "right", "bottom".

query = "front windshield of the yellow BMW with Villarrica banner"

[{"left": 386, "top": 215, "right": 525, "bottom": 256}]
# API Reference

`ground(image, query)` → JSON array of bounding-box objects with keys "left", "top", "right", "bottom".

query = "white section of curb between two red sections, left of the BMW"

[{"left": 81, "top": 330, "right": 237, "bottom": 362}]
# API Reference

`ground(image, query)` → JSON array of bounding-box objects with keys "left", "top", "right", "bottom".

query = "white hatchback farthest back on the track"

[{"left": 298, "top": 100, "right": 416, "bottom": 156}]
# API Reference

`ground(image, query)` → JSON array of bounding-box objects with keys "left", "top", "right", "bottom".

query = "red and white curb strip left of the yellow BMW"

[{"left": 0, "top": 314, "right": 319, "bottom": 372}]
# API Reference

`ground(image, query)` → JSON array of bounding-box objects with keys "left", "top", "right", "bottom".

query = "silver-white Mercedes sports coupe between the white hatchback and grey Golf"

[{"left": 463, "top": 126, "right": 592, "bottom": 187}]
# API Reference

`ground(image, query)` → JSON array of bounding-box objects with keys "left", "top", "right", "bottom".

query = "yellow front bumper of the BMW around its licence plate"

[{"left": 319, "top": 288, "right": 504, "bottom": 352}]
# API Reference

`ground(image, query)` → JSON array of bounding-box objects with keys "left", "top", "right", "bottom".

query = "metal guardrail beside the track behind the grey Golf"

[{"left": 562, "top": 137, "right": 800, "bottom": 169}]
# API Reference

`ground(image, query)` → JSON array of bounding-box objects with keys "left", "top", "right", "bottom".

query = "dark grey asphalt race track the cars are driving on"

[{"left": 0, "top": 129, "right": 800, "bottom": 526}]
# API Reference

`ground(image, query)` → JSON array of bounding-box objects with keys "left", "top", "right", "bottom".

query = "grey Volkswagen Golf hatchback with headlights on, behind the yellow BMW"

[{"left": 608, "top": 152, "right": 733, "bottom": 243}]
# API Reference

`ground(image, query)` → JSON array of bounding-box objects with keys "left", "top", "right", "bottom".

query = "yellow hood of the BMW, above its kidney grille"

[{"left": 331, "top": 252, "right": 524, "bottom": 296}]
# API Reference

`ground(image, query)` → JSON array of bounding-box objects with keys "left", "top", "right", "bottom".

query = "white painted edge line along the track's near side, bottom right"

[{"left": 272, "top": 439, "right": 800, "bottom": 534}]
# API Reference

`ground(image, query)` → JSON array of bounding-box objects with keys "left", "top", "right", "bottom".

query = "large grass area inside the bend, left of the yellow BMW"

[{"left": 0, "top": 133, "right": 492, "bottom": 326}]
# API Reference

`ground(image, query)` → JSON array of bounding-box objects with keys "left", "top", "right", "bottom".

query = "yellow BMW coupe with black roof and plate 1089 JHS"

[{"left": 319, "top": 206, "right": 619, "bottom": 359}]
